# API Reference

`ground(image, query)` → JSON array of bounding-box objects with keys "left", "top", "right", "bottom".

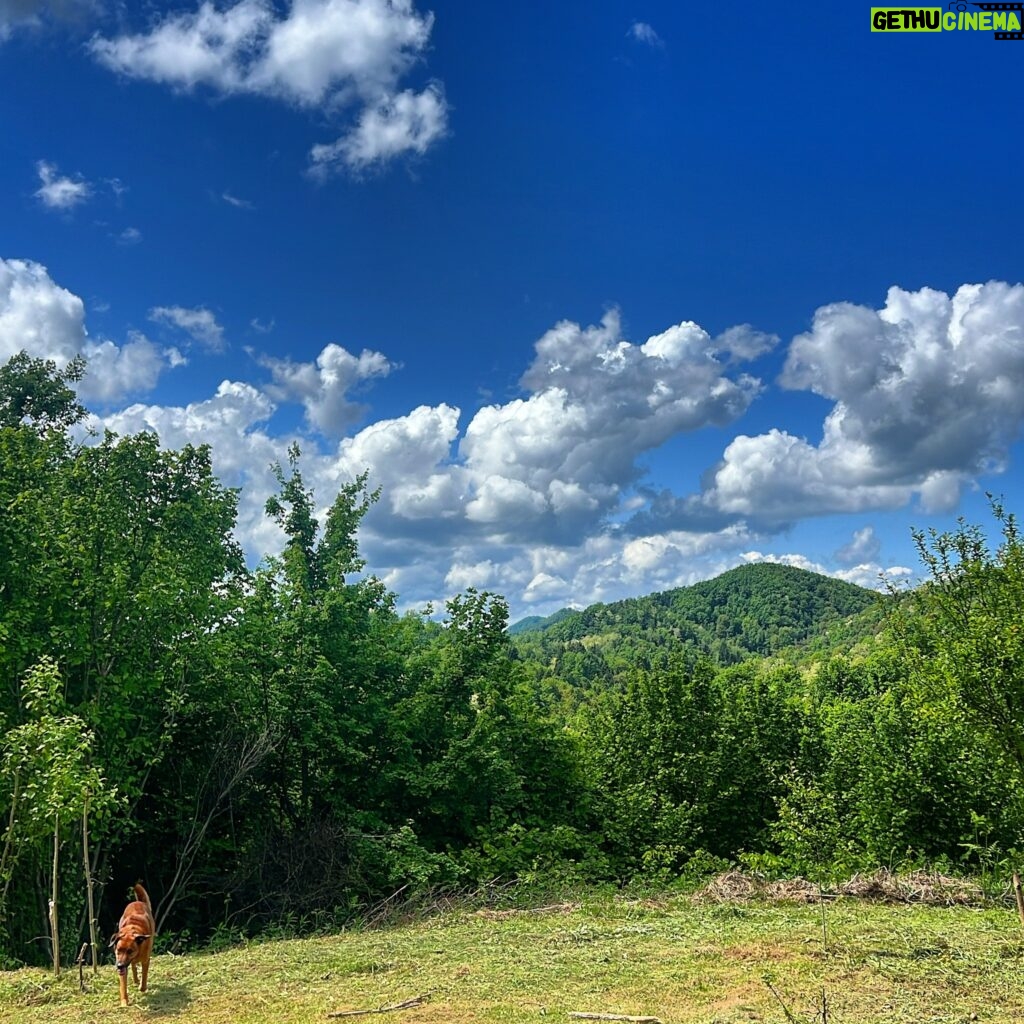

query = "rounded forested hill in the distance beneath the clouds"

[{"left": 510, "top": 562, "right": 885, "bottom": 684}]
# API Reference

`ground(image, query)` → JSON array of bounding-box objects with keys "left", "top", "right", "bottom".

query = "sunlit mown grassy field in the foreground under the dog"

[{"left": 0, "top": 884, "right": 1024, "bottom": 1024}]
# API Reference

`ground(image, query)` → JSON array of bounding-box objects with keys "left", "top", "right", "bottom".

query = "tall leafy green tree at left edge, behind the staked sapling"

[{"left": 0, "top": 359, "right": 242, "bottom": 958}]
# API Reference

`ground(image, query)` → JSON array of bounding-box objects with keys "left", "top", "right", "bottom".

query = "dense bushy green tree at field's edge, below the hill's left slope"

[{"left": 587, "top": 665, "right": 802, "bottom": 877}]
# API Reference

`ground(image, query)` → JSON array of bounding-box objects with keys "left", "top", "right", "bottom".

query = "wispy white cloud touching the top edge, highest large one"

[{"left": 90, "top": 0, "right": 447, "bottom": 173}]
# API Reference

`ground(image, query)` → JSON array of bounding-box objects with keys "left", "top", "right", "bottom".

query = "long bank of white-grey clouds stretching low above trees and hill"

[{"left": 6, "top": 260, "right": 1024, "bottom": 614}]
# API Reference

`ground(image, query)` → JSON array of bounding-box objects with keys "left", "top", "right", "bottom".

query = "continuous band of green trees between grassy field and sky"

[{"left": 0, "top": 356, "right": 1024, "bottom": 964}]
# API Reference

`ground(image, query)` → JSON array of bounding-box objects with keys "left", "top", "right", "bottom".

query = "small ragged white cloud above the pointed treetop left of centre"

[{"left": 257, "top": 344, "right": 394, "bottom": 436}]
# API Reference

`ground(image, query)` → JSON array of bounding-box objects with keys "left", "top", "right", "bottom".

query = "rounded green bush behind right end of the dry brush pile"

[{"left": 775, "top": 684, "right": 1019, "bottom": 872}]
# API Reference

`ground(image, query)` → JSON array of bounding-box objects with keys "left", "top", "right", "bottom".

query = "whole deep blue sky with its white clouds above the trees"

[{"left": 0, "top": 0, "right": 1024, "bottom": 617}]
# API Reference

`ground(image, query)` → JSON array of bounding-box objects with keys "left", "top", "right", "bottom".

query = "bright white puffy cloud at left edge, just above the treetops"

[{"left": 0, "top": 259, "right": 169, "bottom": 402}]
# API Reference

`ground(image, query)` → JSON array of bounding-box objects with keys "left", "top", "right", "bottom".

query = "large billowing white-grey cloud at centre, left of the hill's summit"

[{"left": 460, "top": 310, "right": 761, "bottom": 537}]
